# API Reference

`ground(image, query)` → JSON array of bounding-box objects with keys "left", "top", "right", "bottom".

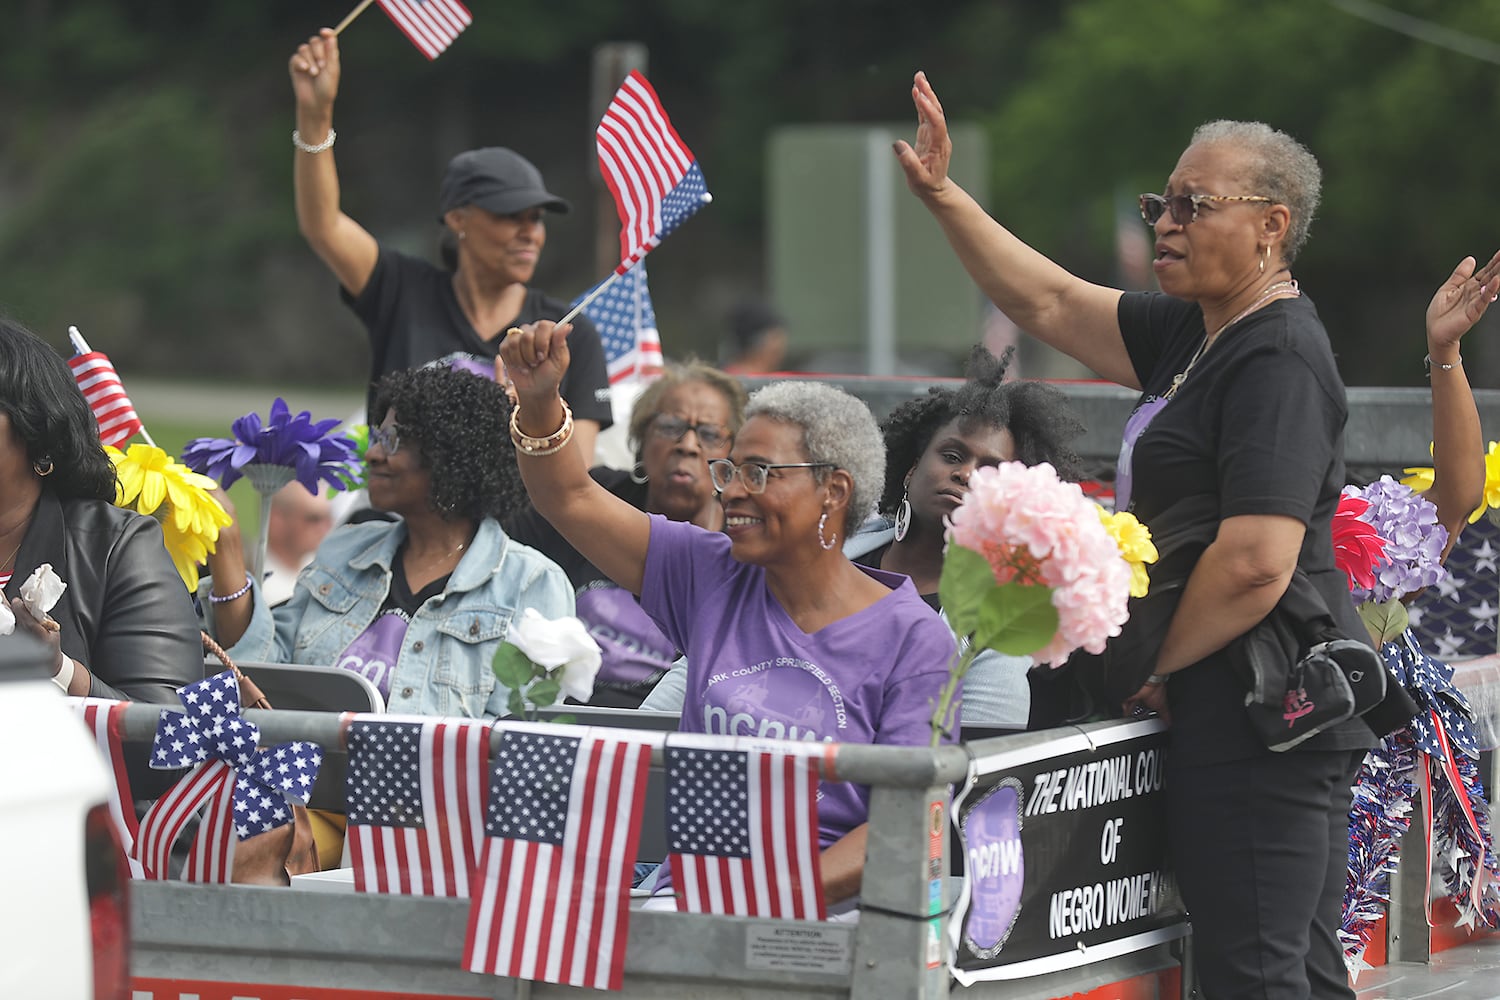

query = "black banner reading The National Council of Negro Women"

[{"left": 950, "top": 720, "right": 1188, "bottom": 987}]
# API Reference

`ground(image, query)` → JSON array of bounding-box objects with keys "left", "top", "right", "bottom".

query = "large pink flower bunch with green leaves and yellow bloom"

[{"left": 933, "top": 462, "right": 1157, "bottom": 747}]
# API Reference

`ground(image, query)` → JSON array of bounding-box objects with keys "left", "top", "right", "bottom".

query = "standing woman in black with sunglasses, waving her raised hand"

[{"left": 896, "top": 73, "right": 1410, "bottom": 1000}]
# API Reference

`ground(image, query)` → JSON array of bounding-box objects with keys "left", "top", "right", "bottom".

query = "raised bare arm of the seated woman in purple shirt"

[{"left": 495, "top": 321, "right": 651, "bottom": 594}]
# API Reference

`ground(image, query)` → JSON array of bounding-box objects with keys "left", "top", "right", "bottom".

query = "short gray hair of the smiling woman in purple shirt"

[{"left": 746, "top": 381, "right": 885, "bottom": 538}]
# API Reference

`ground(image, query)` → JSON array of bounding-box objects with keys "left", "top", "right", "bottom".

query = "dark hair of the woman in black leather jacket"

[{"left": 0, "top": 318, "right": 117, "bottom": 504}]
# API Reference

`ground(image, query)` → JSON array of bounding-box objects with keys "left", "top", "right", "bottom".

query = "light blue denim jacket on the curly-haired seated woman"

[{"left": 214, "top": 520, "right": 573, "bottom": 718}]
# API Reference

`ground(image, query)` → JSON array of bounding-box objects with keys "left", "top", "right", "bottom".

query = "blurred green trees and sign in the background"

[{"left": 0, "top": 0, "right": 1500, "bottom": 401}]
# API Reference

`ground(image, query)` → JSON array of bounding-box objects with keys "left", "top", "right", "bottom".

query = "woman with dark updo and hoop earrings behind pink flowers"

[{"left": 845, "top": 346, "right": 1083, "bottom": 729}]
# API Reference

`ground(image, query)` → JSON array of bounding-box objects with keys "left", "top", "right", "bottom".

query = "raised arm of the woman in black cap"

[{"left": 290, "top": 28, "right": 380, "bottom": 295}]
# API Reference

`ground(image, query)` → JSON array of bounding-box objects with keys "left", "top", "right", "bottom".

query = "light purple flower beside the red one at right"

[{"left": 1344, "top": 475, "right": 1448, "bottom": 603}]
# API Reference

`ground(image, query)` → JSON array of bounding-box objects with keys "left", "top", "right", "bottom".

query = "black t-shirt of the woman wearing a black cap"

[{"left": 339, "top": 246, "right": 614, "bottom": 429}]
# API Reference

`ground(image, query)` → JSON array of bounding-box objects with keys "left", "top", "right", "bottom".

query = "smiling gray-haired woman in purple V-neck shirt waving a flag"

[{"left": 500, "top": 322, "right": 954, "bottom": 906}]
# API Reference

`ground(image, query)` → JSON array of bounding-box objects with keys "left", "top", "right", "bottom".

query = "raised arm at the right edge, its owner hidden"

[{"left": 1427, "top": 253, "right": 1500, "bottom": 559}]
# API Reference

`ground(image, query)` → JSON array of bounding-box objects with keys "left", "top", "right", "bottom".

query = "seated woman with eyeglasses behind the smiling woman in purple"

[{"left": 507, "top": 361, "right": 746, "bottom": 708}]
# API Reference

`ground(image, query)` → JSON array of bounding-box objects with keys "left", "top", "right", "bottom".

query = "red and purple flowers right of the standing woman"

[{"left": 1334, "top": 475, "right": 1448, "bottom": 646}]
